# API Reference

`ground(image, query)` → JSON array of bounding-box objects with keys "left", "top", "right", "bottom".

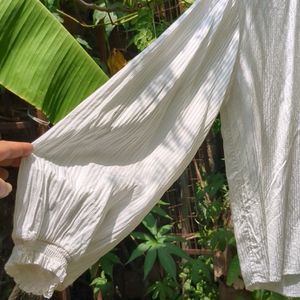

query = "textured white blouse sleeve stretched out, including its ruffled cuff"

[{"left": 6, "top": 0, "right": 239, "bottom": 298}]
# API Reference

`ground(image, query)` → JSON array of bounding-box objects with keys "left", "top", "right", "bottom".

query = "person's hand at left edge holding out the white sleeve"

[{"left": 0, "top": 141, "right": 32, "bottom": 198}]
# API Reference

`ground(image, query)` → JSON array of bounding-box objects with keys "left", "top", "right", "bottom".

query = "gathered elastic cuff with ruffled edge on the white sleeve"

[{"left": 5, "top": 241, "right": 68, "bottom": 298}]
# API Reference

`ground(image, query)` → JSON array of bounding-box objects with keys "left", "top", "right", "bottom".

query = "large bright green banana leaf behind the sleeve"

[{"left": 0, "top": 0, "right": 107, "bottom": 123}]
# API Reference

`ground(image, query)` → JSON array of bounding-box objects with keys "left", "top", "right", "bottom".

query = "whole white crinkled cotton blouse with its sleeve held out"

[{"left": 6, "top": 0, "right": 300, "bottom": 297}]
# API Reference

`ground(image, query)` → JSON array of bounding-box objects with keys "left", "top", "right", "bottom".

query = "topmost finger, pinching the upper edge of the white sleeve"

[{"left": 0, "top": 141, "right": 32, "bottom": 166}]
